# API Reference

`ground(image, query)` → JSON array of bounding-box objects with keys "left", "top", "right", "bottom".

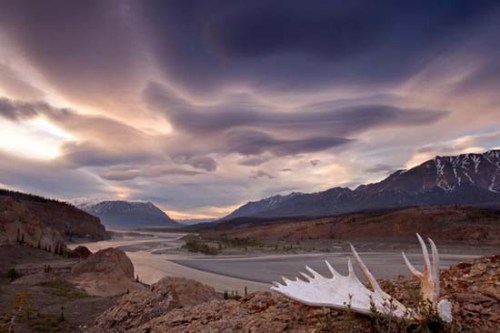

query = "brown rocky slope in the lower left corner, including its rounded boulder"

[{"left": 0, "top": 244, "right": 141, "bottom": 333}]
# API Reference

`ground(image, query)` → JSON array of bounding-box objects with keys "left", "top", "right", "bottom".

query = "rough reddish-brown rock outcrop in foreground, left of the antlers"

[{"left": 89, "top": 277, "right": 222, "bottom": 333}]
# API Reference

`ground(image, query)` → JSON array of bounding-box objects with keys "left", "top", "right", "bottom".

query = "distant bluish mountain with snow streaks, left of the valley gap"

[{"left": 78, "top": 200, "right": 181, "bottom": 228}]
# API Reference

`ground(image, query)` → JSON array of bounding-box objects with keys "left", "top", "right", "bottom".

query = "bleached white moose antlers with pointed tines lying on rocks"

[{"left": 271, "top": 234, "right": 451, "bottom": 322}]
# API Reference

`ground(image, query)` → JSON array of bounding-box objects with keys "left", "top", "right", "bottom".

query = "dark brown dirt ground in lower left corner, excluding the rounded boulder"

[{"left": 0, "top": 245, "right": 117, "bottom": 333}]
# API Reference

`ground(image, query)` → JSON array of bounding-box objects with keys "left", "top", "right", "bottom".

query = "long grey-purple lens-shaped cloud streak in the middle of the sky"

[{"left": 144, "top": 82, "right": 447, "bottom": 156}]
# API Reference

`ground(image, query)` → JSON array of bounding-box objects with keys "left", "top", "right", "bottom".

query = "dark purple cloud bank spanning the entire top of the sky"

[{"left": 0, "top": 0, "right": 500, "bottom": 99}]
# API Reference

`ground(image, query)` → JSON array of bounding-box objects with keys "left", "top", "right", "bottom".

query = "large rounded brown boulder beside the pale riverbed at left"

[{"left": 70, "top": 248, "right": 140, "bottom": 296}]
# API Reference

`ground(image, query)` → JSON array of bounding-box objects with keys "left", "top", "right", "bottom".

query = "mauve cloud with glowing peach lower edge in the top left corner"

[{"left": 0, "top": 0, "right": 147, "bottom": 104}]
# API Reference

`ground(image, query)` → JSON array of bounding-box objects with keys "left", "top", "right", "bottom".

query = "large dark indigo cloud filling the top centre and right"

[{"left": 141, "top": 0, "right": 499, "bottom": 92}]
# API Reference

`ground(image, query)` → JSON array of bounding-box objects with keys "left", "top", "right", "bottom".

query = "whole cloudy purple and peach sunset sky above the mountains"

[{"left": 0, "top": 0, "right": 500, "bottom": 218}]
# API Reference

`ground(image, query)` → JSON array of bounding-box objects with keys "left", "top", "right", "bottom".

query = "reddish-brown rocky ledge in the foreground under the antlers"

[{"left": 86, "top": 256, "right": 500, "bottom": 333}]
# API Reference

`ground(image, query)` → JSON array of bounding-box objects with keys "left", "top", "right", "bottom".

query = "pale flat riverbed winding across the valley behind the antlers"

[{"left": 69, "top": 232, "right": 495, "bottom": 294}]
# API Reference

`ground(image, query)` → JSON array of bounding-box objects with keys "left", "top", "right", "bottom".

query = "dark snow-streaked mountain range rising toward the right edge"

[{"left": 222, "top": 150, "right": 500, "bottom": 221}]
